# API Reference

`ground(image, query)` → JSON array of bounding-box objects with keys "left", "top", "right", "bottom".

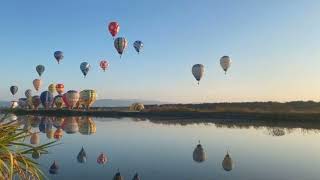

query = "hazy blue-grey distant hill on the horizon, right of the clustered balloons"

[{"left": 93, "top": 99, "right": 166, "bottom": 107}]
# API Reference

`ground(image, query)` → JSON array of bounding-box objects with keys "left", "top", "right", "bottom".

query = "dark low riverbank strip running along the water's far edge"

[{"left": 1, "top": 109, "right": 320, "bottom": 122}]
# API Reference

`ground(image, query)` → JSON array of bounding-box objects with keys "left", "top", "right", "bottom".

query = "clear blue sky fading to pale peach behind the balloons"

[{"left": 0, "top": 0, "right": 320, "bottom": 103}]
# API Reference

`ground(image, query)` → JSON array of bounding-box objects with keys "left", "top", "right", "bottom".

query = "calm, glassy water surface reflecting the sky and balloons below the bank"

[{"left": 15, "top": 117, "right": 320, "bottom": 180}]
